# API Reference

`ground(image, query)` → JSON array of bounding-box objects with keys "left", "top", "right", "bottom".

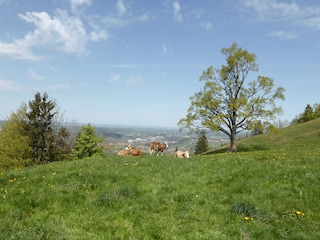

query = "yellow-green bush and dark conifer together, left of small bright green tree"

[{"left": 0, "top": 93, "right": 73, "bottom": 170}]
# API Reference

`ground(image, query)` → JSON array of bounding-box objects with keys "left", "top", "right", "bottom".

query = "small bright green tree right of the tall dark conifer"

[{"left": 71, "top": 124, "right": 103, "bottom": 160}]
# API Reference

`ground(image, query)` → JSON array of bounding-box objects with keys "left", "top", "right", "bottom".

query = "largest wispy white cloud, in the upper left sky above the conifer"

[{"left": 0, "top": 9, "right": 108, "bottom": 60}]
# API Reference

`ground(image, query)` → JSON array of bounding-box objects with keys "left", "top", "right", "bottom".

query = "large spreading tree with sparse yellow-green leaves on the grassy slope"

[{"left": 178, "top": 43, "right": 284, "bottom": 152}]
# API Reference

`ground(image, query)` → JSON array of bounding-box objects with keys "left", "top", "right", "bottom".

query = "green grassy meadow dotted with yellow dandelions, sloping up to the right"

[{"left": 0, "top": 119, "right": 320, "bottom": 240}]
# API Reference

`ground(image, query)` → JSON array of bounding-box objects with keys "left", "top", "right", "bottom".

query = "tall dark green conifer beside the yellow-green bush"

[{"left": 25, "top": 92, "right": 57, "bottom": 163}]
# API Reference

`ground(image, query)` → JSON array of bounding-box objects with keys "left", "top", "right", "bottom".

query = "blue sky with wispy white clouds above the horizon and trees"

[{"left": 0, "top": 0, "right": 320, "bottom": 127}]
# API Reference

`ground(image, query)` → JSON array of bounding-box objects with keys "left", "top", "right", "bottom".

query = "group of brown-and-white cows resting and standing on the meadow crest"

[{"left": 117, "top": 142, "right": 190, "bottom": 158}]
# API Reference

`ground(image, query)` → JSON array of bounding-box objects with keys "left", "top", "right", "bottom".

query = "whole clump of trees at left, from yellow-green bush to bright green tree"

[{"left": 0, "top": 92, "right": 103, "bottom": 171}]
